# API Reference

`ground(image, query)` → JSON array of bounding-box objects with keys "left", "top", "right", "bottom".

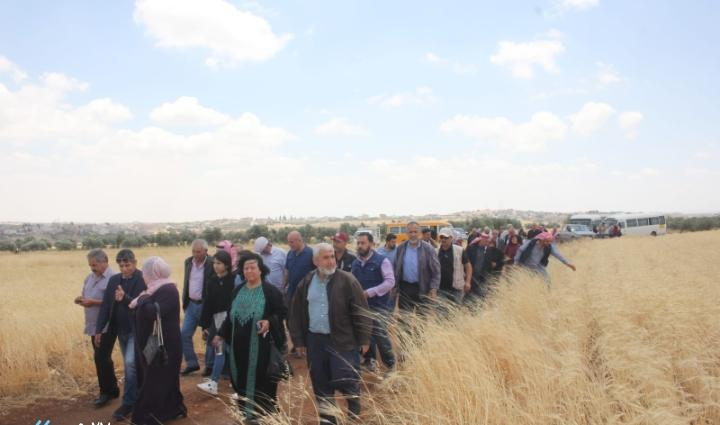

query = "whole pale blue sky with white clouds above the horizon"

[{"left": 0, "top": 0, "right": 720, "bottom": 222}]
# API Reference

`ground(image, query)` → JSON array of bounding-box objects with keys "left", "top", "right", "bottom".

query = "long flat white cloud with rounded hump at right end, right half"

[{"left": 440, "top": 112, "right": 567, "bottom": 151}]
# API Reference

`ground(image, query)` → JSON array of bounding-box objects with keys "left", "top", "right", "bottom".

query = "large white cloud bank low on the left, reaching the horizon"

[{"left": 0, "top": 63, "right": 302, "bottom": 221}]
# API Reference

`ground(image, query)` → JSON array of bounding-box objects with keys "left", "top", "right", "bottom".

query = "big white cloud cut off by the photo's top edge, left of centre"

[{"left": 133, "top": 0, "right": 292, "bottom": 67}]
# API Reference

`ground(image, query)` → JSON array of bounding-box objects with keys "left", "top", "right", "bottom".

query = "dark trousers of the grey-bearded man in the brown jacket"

[{"left": 306, "top": 333, "right": 360, "bottom": 424}]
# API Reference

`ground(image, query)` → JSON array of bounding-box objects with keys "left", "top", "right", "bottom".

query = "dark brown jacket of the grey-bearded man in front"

[{"left": 288, "top": 270, "right": 372, "bottom": 351}]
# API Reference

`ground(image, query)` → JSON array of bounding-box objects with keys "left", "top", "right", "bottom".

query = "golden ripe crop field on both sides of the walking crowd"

[{"left": 0, "top": 231, "right": 720, "bottom": 425}]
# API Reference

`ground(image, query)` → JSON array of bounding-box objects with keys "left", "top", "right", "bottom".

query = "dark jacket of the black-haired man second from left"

[{"left": 95, "top": 270, "right": 145, "bottom": 335}]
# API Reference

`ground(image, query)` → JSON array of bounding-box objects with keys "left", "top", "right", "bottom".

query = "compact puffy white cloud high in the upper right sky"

[{"left": 490, "top": 40, "right": 565, "bottom": 79}]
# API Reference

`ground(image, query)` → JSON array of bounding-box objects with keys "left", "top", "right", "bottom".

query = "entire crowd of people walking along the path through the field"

[{"left": 75, "top": 222, "right": 575, "bottom": 425}]
